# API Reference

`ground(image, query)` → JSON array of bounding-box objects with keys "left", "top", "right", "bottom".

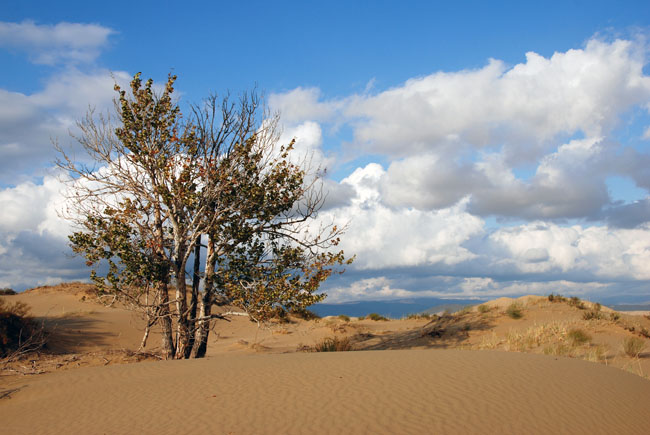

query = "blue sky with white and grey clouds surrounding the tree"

[{"left": 0, "top": 1, "right": 650, "bottom": 302}]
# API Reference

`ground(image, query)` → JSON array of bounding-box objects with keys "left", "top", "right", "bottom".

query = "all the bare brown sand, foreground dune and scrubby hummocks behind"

[{"left": 0, "top": 285, "right": 650, "bottom": 434}]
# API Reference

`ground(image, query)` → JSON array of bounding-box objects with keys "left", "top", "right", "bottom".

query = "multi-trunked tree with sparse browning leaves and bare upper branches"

[{"left": 57, "top": 73, "right": 351, "bottom": 358}]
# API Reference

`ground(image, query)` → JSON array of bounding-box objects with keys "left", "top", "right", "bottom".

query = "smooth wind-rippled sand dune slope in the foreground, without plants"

[{"left": 0, "top": 350, "right": 650, "bottom": 434}]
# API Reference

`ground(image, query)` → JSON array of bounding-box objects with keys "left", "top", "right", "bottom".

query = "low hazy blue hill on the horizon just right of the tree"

[{"left": 310, "top": 298, "right": 481, "bottom": 319}]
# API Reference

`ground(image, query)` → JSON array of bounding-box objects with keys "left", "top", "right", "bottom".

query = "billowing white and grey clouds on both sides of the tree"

[{"left": 0, "top": 28, "right": 650, "bottom": 302}]
